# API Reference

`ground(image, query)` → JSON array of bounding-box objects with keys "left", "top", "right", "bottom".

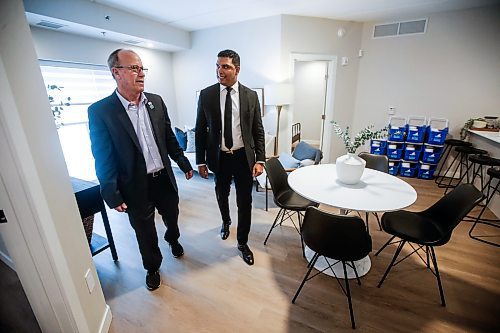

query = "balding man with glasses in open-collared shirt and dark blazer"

[{"left": 88, "top": 49, "right": 193, "bottom": 290}]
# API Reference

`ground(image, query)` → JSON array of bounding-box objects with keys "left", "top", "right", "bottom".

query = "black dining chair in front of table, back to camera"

[{"left": 292, "top": 207, "right": 372, "bottom": 328}]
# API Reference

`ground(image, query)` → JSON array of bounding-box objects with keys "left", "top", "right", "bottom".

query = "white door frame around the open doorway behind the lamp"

[{"left": 289, "top": 52, "right": 338, "bottom": 163}]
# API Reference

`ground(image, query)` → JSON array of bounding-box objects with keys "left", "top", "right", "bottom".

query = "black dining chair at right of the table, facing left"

[{"left": 375, "top": 184, "right": 484, "bottom": 306}]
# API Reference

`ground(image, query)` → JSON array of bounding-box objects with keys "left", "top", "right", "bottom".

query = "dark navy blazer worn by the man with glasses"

[{"left": 88, "top": 92, "right": 192, "bottom": 208}]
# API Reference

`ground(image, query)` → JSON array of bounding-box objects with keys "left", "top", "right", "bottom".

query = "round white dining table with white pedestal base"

[{"left": 288, "top": 164, "right": 417, "bottom": 279}]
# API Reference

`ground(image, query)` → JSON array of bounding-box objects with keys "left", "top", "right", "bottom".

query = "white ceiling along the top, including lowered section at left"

[{"left": 24, "top": 0, "right": 500, "bottom": 52}]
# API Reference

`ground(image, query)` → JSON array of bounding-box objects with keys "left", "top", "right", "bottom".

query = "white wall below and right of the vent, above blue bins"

[{"left": 354, "top": 6, "right": 500, "bottom": 137}]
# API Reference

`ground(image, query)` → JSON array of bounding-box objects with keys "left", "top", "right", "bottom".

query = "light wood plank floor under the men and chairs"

[{"left": 94, "top": 173, "right": 500, "bottom": 333}]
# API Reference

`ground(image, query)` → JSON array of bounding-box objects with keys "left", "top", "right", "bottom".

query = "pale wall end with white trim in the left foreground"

[{"left": 0, "top": 0, "right": 111, "bottom": 332}]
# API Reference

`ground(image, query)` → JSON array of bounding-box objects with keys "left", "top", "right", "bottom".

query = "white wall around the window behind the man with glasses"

[{"left": 31, "top": 27, "right": 177, "bottom": 123}]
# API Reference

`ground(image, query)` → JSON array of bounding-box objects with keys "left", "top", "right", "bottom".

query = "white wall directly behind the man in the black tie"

[{"left": 173, "top": 16, "right": 281, "bottom": 129}]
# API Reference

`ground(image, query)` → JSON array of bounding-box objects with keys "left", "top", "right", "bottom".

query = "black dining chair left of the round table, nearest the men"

[{"left": 264, "top": 157, "right": 319, "bottom": 256}]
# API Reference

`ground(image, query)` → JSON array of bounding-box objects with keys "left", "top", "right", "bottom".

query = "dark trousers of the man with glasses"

[{"left": 127, "top": 171, "right": 180, "bottom": 271}]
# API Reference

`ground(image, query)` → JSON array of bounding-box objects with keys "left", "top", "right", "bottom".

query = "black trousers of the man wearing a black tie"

[{"left": 215, "top": 148, "right": 253, "bottom": 244}]
